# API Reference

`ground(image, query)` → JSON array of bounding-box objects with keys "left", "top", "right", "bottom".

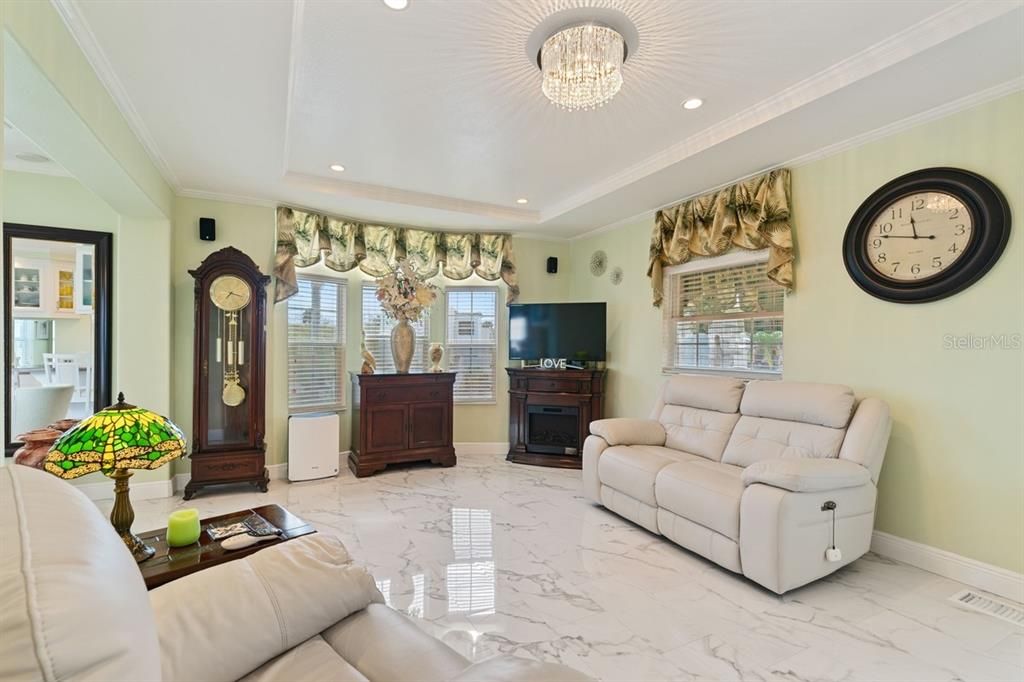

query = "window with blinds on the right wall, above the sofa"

[{"left": 663, "top": 251, "right": 785, "bottom": 375}]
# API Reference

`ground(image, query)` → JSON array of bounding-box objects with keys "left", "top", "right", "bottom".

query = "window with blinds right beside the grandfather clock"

[{"left": 288, "top": 274, "right": 348, "bottom": 413}]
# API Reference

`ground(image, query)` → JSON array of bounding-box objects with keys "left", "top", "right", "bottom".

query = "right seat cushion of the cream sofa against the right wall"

[{"left": 654, "top": 460, "right": 743, "bottom": 541}]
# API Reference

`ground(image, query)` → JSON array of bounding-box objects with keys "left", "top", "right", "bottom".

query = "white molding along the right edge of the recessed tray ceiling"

[{"left": 541, "top": 0, "right": 1019, "bottom": 222}]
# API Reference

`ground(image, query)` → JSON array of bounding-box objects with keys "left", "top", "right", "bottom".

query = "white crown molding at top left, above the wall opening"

[{"left": 50, "top": 0, "right": 181, "bottom": 193}]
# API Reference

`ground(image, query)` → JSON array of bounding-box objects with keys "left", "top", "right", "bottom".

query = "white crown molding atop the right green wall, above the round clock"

[{"left": 568, "top": 77, "right": 1024, "bottom": 241}]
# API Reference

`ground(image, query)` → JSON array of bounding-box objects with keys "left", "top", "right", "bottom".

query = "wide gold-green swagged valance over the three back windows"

[{"left": 273, "top": 206, "right": 519, "bottom": 303}]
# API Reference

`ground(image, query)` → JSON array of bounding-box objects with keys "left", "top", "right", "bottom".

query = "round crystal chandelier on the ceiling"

[{"left": 541, "top": 24, "right": 626, "bottom": 112}]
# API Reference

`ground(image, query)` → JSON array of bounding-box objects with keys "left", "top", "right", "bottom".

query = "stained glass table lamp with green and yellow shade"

[{"left": 43, "top": 393, "right": 185, "bottom": 561}]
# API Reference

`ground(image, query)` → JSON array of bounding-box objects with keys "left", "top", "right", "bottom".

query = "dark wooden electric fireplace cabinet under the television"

[{"left": 506, "top": 368, "right": 604, "bottom": 469}]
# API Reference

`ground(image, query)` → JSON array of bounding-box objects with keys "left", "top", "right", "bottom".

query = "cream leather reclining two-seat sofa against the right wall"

[{"left": 583, "top": 375, "right": 891, "bottom": 594}]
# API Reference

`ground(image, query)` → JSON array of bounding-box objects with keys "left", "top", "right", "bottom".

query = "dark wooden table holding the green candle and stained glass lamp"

[{"left": 138, "top": 505, "right": 316, "bottom": 590}]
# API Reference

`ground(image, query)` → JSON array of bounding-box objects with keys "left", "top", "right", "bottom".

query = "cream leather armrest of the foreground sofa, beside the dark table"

[{"left": 150, "top": 534, "right": 384, "bottom": 682}]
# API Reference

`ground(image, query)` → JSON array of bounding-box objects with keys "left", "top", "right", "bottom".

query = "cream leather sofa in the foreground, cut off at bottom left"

[{"left": 0, "top": 465, "right": 586, "bottom": 682}]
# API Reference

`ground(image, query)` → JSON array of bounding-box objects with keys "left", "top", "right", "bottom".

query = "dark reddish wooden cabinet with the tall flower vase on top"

[{"left": 348, "top": 372, "right": 455, "bottom": 476}]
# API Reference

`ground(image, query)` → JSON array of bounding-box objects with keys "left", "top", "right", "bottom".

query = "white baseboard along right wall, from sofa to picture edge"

[{"left": 871, "top": 530, "right": 1024, "bottom": 603}]
